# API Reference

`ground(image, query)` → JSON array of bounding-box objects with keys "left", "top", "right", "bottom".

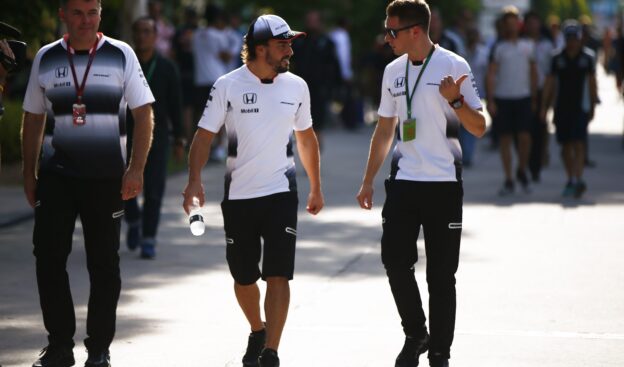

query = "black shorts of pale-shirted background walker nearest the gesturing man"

[{"left": 494, "top": 97, "right": 533, "bottom": 135}]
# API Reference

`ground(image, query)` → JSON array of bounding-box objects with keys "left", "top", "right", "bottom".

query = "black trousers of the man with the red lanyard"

[{"left": 33, "top": 173, "right": 123, "bottom": 352}]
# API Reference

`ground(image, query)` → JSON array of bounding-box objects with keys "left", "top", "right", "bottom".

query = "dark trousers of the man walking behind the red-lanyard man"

[{"left": 125, "top": 144, "right": 169, "bottom": 238}]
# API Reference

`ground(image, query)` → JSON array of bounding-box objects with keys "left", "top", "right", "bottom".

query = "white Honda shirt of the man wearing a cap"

[{"left": 199, "top": 65, "right": 312, "bottom": 200}]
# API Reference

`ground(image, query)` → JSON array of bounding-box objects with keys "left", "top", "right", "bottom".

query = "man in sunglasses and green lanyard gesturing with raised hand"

[{"left": 357, "top": 0, "right": 485, "bottom": 367}]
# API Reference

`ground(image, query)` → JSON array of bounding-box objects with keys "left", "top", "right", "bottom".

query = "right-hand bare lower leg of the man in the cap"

[{"left": 264, "top": 277, "right": 290, "bottom": 350}]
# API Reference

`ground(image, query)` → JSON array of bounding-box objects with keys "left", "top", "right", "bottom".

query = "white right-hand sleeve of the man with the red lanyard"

[{"left": 124, "top": 45, "right": 155, "bottom": 110}]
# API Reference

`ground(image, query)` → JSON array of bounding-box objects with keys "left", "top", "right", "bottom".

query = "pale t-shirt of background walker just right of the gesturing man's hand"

[{"left": 491, "top": 38, "right": 535, "bottom": 99}]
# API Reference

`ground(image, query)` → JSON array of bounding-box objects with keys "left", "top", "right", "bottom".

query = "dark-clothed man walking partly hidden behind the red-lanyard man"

[{"left": 125, "top": 17, "right": 186, "bottom": 259}]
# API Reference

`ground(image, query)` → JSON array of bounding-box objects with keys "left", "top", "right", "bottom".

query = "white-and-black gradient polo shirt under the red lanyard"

[{"left": 23, "top": 36, "right": 154, "bottom": 178}]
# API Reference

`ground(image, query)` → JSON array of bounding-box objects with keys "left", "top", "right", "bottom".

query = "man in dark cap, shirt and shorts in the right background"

[{"left": 540, "top": 20, "right": 598, "bottom": 198}]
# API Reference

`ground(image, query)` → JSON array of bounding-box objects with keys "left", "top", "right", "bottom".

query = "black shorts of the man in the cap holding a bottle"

[{"left": 221, "top": 192, "right": 299, "bottom": 285}]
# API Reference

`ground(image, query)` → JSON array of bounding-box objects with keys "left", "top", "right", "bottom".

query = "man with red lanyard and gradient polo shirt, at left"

[{"left": 22, "top": 0, "right": 154, "bottom": 367}]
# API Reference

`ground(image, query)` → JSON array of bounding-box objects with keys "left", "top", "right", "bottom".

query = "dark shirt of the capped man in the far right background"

[{"left": 550, "top": 47, "right": 596, "bottom": 118}]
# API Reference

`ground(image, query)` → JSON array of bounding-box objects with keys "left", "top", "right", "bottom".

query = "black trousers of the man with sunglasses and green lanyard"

[{"left": 381, "top": 180, "right": 463, "bottom": 358}]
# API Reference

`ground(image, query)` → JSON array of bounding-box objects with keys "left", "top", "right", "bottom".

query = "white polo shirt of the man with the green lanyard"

[{"left": 378, "top": 46, "right": 481, "bottom": 181}]
